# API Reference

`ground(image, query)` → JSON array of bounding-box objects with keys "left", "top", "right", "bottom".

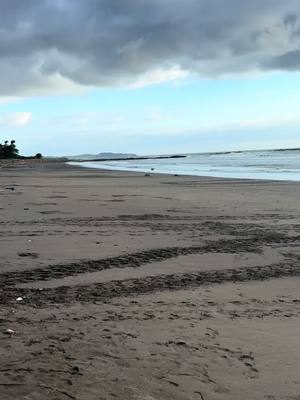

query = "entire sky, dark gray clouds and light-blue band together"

[{"left": 0, "top": 0, "right": 300, "bottom": 156}]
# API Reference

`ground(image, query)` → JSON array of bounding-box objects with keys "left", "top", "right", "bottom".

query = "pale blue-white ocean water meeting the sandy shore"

[{"left": 70, "top": 149, "right": 300, "bottom": 181}]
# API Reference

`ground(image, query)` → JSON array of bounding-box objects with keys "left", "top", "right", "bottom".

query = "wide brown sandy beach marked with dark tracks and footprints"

[{"left": 0, "top": 160, "right": 300, "bottom": 400}]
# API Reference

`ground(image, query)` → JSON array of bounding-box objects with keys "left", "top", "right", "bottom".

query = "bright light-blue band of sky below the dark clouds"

[{"left": 0, "top": 72, "right": 300, "bottom": 155}]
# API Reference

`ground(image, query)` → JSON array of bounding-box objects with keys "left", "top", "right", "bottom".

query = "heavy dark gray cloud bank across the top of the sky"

[{"left": 0, "top": 0, "right": 300, "bottom": 96}]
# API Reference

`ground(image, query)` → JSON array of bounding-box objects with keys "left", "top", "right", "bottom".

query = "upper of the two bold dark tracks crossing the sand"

[{"left": 0, "top": 234, "right": 300, "bottom": 288}]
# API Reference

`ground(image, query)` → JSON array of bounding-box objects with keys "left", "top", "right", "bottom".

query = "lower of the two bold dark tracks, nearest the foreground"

[{"left": 0, "top": 262, "right": 300, "bottom": 306}]
